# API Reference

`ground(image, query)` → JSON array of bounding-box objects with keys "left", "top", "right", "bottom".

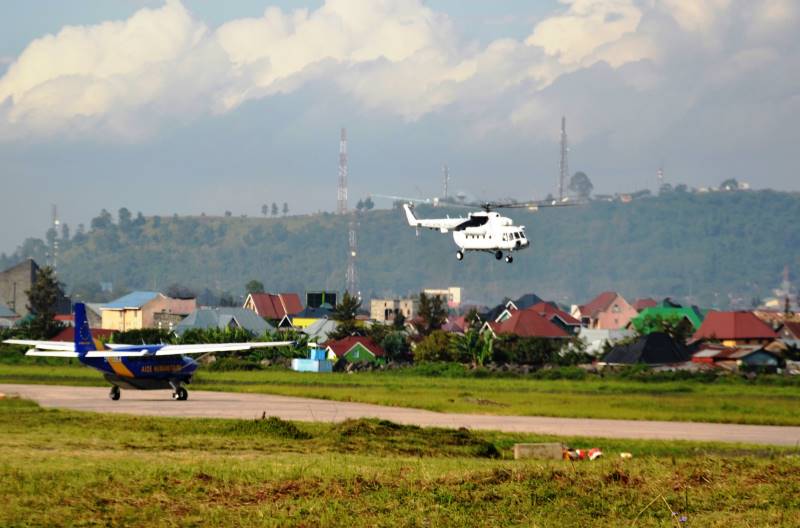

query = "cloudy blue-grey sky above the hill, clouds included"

[{"left": 0, "top": 0, "right": 800, "bottom": 252}]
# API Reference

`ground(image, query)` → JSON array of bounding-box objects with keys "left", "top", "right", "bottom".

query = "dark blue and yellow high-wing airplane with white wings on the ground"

[{"left": 3, "top": 303, "right": 294, "bottom": 400}]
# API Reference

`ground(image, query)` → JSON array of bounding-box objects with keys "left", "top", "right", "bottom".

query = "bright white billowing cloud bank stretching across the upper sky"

[{"left": 0, "top": 0, "right": 798, "bottom": 147}]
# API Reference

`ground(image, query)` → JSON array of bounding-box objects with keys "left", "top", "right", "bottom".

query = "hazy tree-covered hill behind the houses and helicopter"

[{"left": 0, "top": 191, "right": 800, "bottom": 307}]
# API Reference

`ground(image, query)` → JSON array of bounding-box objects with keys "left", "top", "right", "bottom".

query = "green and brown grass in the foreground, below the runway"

[{"left": 0, "top": 399, "right": 800, "bottom": 528}]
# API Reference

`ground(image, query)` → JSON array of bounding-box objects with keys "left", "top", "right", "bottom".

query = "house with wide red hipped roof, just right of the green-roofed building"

[{"left": 692, "top": 311, "right": 778, "bottom": 347}]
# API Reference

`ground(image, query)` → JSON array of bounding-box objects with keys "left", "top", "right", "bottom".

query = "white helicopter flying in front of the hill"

[{"left": 386, "top": 196, "right": 578, "bottom": 264}]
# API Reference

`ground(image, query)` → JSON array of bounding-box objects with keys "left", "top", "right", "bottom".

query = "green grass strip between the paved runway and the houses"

[{"left": 0, "top": 364, "right": 800, "bottom": 425}]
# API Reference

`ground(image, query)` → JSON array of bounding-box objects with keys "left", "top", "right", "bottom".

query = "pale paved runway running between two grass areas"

[{"left": 0, "top": 384, "right": 800, "bottom": 446}]
